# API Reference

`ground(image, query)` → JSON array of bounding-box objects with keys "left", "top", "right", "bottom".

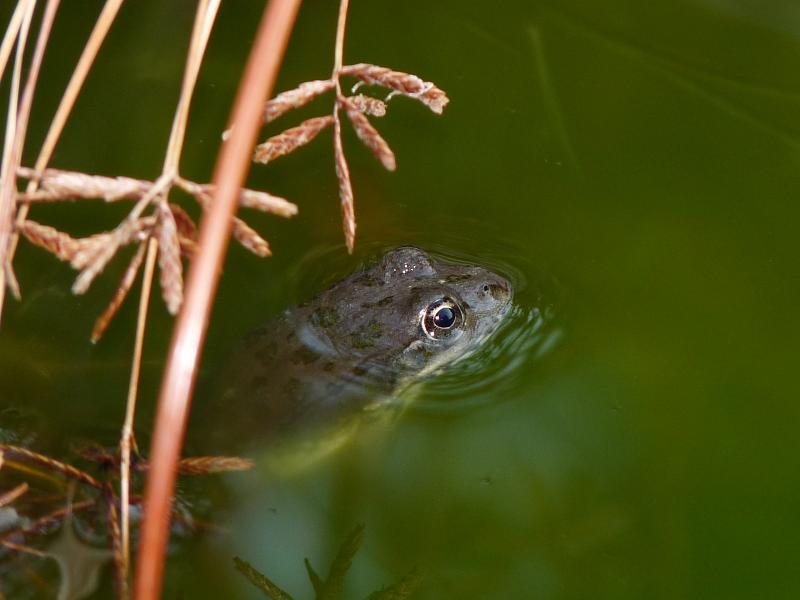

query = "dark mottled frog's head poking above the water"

[{"left": 317, "top": 246, "right": 513, "bottom": 378}]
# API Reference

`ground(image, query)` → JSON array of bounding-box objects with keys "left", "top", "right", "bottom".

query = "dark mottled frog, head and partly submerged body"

[{"left": 212, "top": 246, "right": 512, "bottom": 458}]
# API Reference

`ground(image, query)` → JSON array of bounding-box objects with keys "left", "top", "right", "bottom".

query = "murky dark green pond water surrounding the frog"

[{"left": 0, "top": 0, "right": 800, "bottom": 599}]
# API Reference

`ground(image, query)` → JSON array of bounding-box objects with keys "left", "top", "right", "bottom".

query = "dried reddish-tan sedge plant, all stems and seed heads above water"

[{"left": 0, "top": 0, "right": 448, "bottom": 598}]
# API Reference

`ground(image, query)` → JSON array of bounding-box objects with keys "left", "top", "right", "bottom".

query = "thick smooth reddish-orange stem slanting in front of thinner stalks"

[{"left": 134, "top": 0, "right": 300, "bottom": 600}]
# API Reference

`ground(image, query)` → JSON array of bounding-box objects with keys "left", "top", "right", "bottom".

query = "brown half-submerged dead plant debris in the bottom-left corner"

[{"left": 0, "top": 444, "right": 253, "bottom": 598}]
